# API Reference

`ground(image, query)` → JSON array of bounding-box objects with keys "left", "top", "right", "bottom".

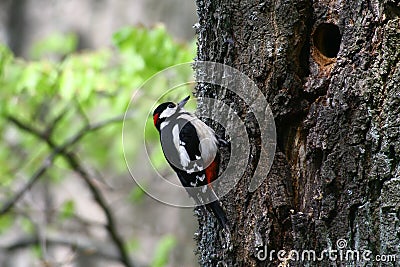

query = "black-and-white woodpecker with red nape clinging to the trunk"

[{"left": 153, "top": 96, "right": 228, "bottom": 229}]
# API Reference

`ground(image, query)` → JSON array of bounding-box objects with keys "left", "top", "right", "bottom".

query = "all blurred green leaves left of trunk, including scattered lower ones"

[{"left": 0, "top": 26, "right": 195, "bottom": 266}]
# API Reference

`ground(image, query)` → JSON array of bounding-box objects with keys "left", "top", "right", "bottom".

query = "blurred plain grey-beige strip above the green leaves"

[{"left": 0, "top": 0, "right": 197, "bottom": 57}]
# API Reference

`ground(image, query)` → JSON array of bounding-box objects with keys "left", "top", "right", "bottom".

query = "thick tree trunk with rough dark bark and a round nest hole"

[{"left": 197, "top": 0, "right": 400, "bottom": 266}]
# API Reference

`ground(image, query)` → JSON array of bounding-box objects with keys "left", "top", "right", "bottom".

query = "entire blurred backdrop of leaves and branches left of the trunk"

[{"left": 0, "top": 0, "right": 197, "bottom": 267}]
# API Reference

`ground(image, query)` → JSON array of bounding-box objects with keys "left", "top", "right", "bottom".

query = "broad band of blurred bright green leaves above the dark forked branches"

[{"left": 0, "top": 26, "right": 194, "bottom": 176}]
